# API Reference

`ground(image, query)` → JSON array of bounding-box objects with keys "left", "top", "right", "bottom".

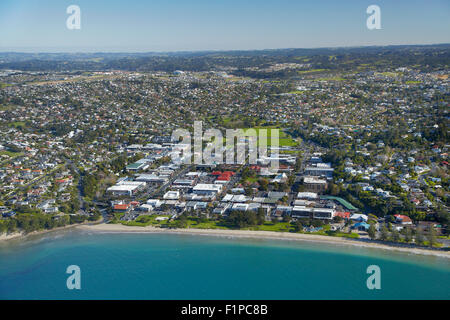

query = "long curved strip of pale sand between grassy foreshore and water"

[{"left": 75, "top": 223, "right": 450, "bottom": 259}]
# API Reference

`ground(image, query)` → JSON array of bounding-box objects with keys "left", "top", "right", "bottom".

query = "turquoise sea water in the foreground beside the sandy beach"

[{"left": 0, "top": 230, "right": 450, "bottom": 299}]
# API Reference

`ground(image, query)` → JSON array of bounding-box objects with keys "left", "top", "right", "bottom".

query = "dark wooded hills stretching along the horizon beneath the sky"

[{"left": 0, "top": 44, "right": 450, "bottom": 77}]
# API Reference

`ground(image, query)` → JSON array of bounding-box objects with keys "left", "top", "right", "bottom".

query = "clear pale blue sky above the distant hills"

[{"left": 0, "top": 0, "right": 450, "bottom": 52}]
